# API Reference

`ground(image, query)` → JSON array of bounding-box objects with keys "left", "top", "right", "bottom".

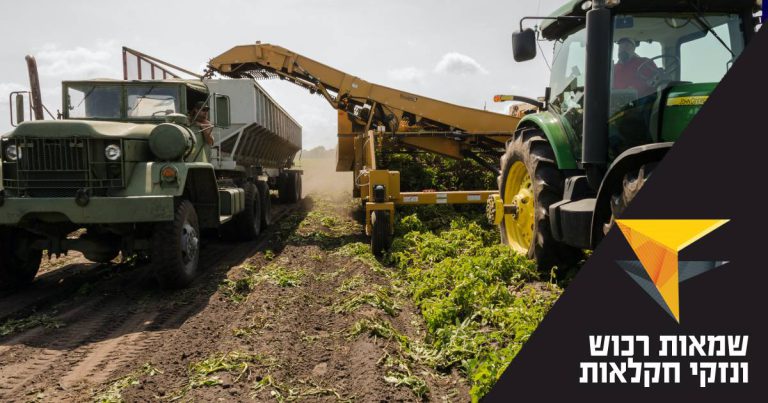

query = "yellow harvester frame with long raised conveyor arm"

[{"left": 207, "top": 43, "right": 520, "bottom": 255}]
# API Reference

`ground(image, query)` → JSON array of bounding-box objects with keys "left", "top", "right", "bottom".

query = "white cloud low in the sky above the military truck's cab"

[{"left": 35, "top": 41, "right": 121, "bottom": 79}]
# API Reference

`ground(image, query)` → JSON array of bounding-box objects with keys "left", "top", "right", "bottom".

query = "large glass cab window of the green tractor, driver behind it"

[{"left": 609, "top": 13, "right": 744, "bottom": 158}]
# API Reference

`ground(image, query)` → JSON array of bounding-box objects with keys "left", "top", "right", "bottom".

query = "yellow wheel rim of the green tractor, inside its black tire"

[{"left": 502, "top": 161, "right": 536, "bottom": 254}]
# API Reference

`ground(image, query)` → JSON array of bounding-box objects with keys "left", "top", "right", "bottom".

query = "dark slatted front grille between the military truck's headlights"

[{"left": 3, "top": 137, "right": 124, "bottom": 197}]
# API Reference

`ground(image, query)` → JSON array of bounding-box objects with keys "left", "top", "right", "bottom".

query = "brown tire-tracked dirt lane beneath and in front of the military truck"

[{"left": 0, "top": 202, "right": 299, "bottom": 401}]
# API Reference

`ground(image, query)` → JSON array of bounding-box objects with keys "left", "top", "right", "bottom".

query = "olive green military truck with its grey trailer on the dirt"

[{"left": 0, "top": 79, "right": 301, "bottom": 289}]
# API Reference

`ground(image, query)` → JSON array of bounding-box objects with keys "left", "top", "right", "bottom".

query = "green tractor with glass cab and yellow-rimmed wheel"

[{"left": 488, "top": 0, "right": 760, "bottom": 270}]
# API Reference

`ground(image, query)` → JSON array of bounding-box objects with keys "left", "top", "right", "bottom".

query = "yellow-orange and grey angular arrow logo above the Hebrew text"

[{"left": 616, "top": 220, "right": 729, "bottom": 323}]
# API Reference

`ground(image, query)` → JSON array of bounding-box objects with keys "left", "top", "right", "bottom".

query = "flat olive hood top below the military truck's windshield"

[{"left": 4, "top": 120, "right": 157, "bottom": 139}]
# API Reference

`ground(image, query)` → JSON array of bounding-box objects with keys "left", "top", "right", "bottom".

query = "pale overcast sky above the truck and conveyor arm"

[{"left": 0, "top": 0, "right": 564, "bottom": 148}]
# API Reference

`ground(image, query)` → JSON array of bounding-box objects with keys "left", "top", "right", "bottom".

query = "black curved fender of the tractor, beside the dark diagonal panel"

[{"left": 590, "top": 142, "right": 674, "bottom": 248}]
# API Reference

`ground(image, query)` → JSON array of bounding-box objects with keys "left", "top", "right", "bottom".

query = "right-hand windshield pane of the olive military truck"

[{"left": 126, "top": 85, "right": 179, "bottom": 118}]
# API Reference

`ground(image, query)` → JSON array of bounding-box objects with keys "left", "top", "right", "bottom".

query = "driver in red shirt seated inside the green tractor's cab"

[{"left": 613, "top": 38, "right": 660, "bottom": 98}]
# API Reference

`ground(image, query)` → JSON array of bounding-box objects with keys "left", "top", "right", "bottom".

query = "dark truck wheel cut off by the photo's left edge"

[{"left": 0, "top": 228, "right": 43, "bottom": 290}]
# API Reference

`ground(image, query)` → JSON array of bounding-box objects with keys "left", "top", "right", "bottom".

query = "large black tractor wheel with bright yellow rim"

[{"left": 498, "top": 128, "right": 581, "bottom": 271}]
